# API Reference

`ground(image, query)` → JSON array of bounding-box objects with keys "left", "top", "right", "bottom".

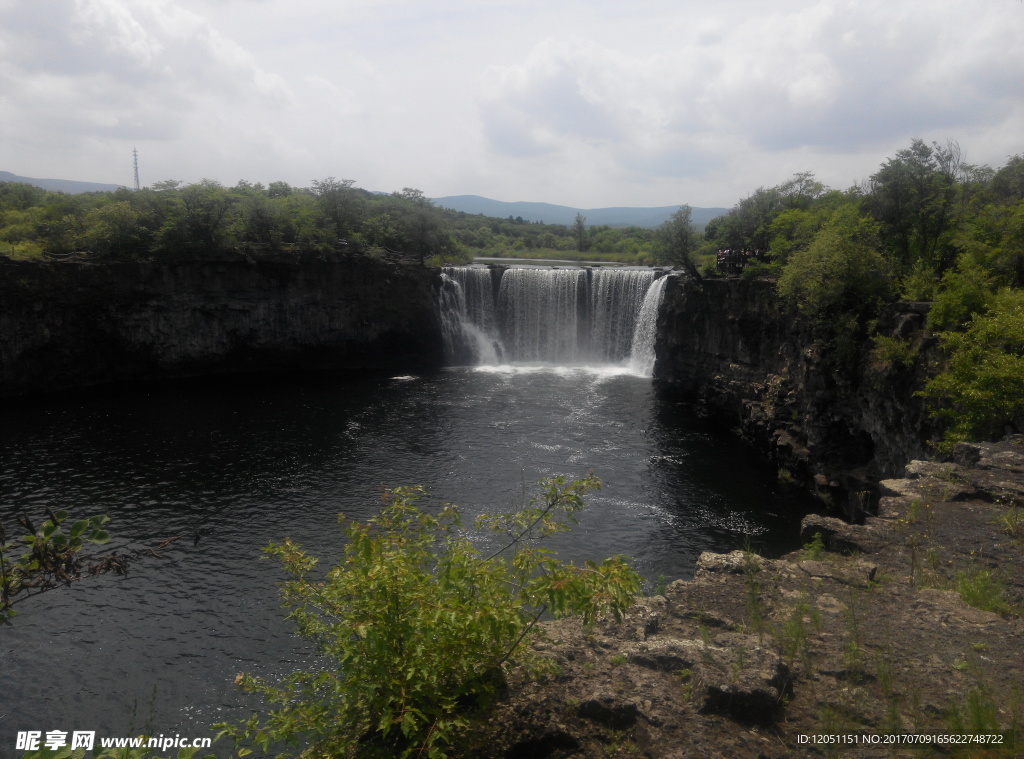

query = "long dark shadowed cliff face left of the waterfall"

[{"left": 0, "top": 256, "right": 442, "bottom": 395}]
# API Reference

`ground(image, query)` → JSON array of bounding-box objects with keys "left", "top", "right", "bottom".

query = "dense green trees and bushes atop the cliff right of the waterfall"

[{"left": 696, "top": 139, "right": 1024, "bottom": 441}]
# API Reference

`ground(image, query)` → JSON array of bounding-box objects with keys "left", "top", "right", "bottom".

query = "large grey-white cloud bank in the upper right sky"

[{"left": 466, "top": 2, "right": 1024, "bottom": 203}]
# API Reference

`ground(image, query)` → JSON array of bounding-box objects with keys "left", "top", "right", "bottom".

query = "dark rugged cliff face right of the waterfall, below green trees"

[{"left": 655, "top": 276, "right": 931, "bottom": 517}]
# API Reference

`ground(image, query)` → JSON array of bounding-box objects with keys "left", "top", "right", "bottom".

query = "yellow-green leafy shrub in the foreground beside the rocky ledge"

[{"left": 218, "top": 476, "right": 640, "bottom": 757}]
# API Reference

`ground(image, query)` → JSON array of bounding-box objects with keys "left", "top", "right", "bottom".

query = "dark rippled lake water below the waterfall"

[{"left": 0, "top": 367, "right": 805, "bottom": 756}]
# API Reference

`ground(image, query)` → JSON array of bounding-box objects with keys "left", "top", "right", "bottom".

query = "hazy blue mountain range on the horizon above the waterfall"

[{"left": 431, "top": 195, "right": 729, "bottom": 227}]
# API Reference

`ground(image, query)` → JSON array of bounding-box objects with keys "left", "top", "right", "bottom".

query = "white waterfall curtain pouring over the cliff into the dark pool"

[{"left": 439, "top": 266, "right": 665, "bottom": 376}]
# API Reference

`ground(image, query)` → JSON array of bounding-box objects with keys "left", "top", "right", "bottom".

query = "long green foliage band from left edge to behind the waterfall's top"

[{"left": 0, "top": 177, "right": 671, "bottom": 263}]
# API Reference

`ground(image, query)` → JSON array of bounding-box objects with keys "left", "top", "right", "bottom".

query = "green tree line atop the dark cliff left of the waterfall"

[{"left": 0, "top": 177, "right": 458, "bottom": 262}]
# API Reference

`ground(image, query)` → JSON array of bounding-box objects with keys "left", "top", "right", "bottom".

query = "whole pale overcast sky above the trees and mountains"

[{"left": 0, "top": 0, "right": 1024, "bottom": 208}]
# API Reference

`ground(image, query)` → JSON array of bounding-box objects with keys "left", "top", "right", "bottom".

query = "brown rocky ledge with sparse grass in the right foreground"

[{"left": 468, "top": 436, "right": 1024, "bottom": 759}]
